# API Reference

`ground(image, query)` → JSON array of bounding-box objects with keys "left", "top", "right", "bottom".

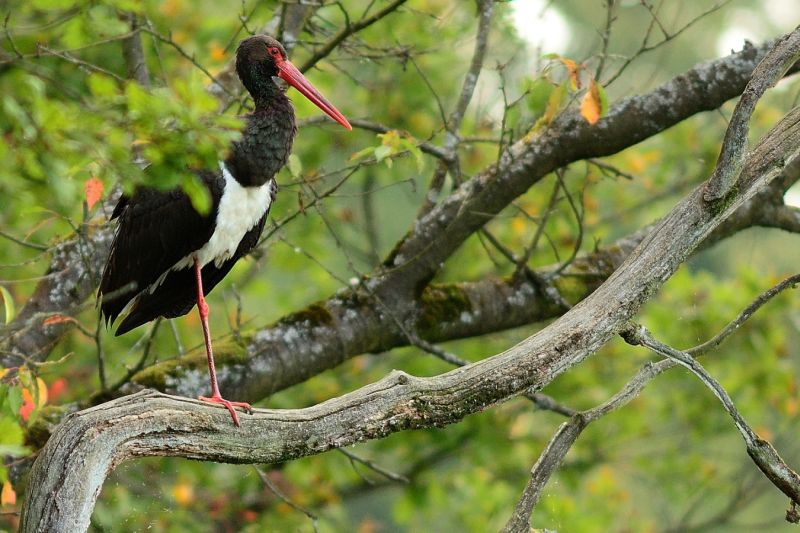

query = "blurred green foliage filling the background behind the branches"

[{"left": 0, "top": 0, "right": 800, "bottom": 532}]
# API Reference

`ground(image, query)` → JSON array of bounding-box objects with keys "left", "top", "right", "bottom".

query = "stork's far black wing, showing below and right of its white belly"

[{"left": 115, "top": 209, "right": 269, "bottom": 335}]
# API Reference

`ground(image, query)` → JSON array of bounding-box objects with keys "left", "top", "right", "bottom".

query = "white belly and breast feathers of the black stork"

[{"left": 149, "top": 161, "right": 275, "bottom": 293}]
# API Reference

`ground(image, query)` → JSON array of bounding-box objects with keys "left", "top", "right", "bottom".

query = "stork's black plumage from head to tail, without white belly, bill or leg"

[{"left": 100, "top": 36, "right": 297, "bottom": 328}]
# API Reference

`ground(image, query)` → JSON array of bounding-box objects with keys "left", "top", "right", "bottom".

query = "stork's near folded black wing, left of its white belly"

[{"left": 99, "top": 172, "right": 225, "bottom": 328}]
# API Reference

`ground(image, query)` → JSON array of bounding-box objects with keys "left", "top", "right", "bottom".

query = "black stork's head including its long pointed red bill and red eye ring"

[{"left": 236, "top": 35, "right": 352, "bottom": 130}]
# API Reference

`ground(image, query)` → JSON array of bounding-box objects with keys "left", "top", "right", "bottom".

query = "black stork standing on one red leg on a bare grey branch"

[{"left": 99, "top": 35, "right": 352, "bottom": 426}]
